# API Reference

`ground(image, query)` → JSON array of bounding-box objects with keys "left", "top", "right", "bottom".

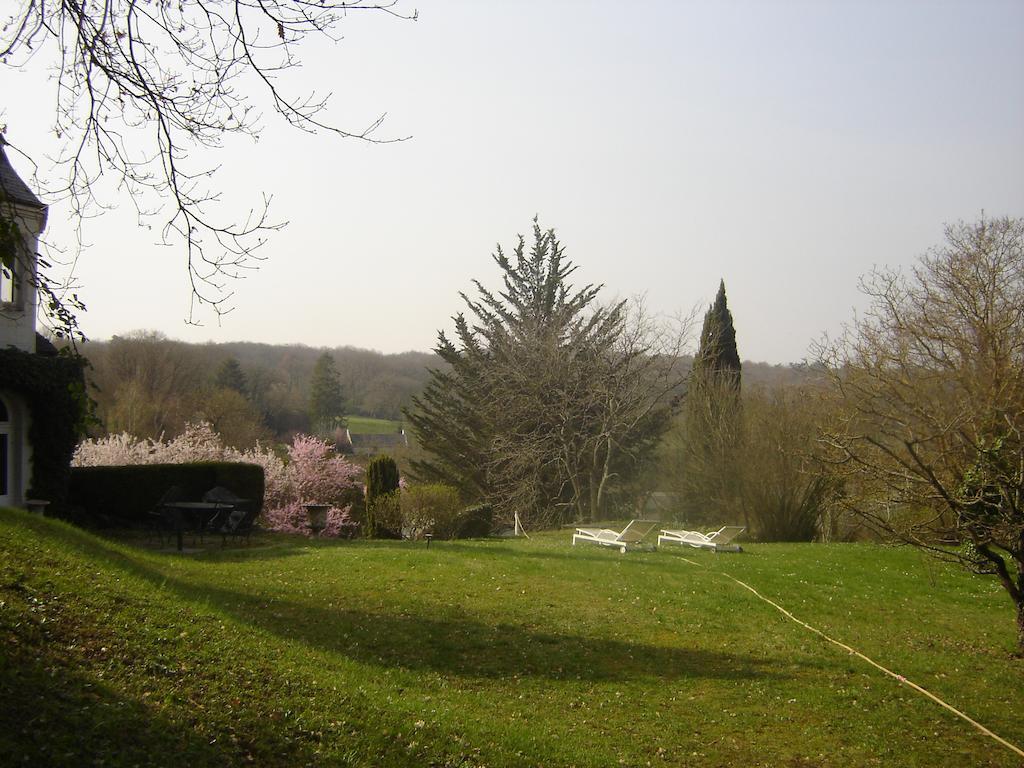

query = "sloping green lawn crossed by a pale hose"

[{"left": 0, "top": 511, "right": 1024, "bottom": 768}]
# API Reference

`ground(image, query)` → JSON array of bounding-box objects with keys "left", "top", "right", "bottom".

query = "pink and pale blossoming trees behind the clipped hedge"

[{"left": 72, "top": 422, "right": 362, "bottom": 538}]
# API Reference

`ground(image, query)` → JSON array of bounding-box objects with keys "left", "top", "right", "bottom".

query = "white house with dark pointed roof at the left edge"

[{"left": 0, "top": 135, "right": 46, "bottom": 507}]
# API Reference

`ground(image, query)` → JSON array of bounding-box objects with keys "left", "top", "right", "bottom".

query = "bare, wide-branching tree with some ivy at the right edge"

[{"left": 819, "top": 217, "right": 1024, "bottom": 651}]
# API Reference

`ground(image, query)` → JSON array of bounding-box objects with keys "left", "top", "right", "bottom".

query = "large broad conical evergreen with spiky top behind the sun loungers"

[{"left": 407, "top": 220, "right": 684, "bottom": 522}]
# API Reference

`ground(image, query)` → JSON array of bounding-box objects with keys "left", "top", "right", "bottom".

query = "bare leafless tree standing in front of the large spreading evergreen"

[{"left": 485, "top": 301, "right": 692, "bottom": 525}]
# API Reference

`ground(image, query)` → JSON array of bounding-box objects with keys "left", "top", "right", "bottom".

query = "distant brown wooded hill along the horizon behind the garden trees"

[{"left": 82, "top": 332, "right": 807, "bottom": 444}]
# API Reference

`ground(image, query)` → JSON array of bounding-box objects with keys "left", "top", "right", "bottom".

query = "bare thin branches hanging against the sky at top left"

[{"left": 0, "top": 0, "right": 416, "bottom": 331}]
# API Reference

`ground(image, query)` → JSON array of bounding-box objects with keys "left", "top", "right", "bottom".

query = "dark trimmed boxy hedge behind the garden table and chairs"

[{"left": 71, "top": 462, "right": 263, "bottom": 524}]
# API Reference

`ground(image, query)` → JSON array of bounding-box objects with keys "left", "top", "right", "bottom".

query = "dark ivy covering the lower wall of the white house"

[{"left": 0, "top": 349, "right": 91, "bottom": 511}]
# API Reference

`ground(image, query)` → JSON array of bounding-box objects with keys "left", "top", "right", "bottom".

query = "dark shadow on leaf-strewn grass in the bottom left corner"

[{"left": 0, "top": 584, "right": 313, "bottom": 768}]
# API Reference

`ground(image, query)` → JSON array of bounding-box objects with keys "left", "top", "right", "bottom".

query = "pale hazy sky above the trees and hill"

[{"left": 0, "top": 0, "right": 1024, "bottom": 364}]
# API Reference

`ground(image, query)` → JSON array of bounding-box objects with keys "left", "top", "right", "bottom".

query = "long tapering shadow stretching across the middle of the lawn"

[{"left": 18, "top": 520, "right": 780, "bottom": 681}]
